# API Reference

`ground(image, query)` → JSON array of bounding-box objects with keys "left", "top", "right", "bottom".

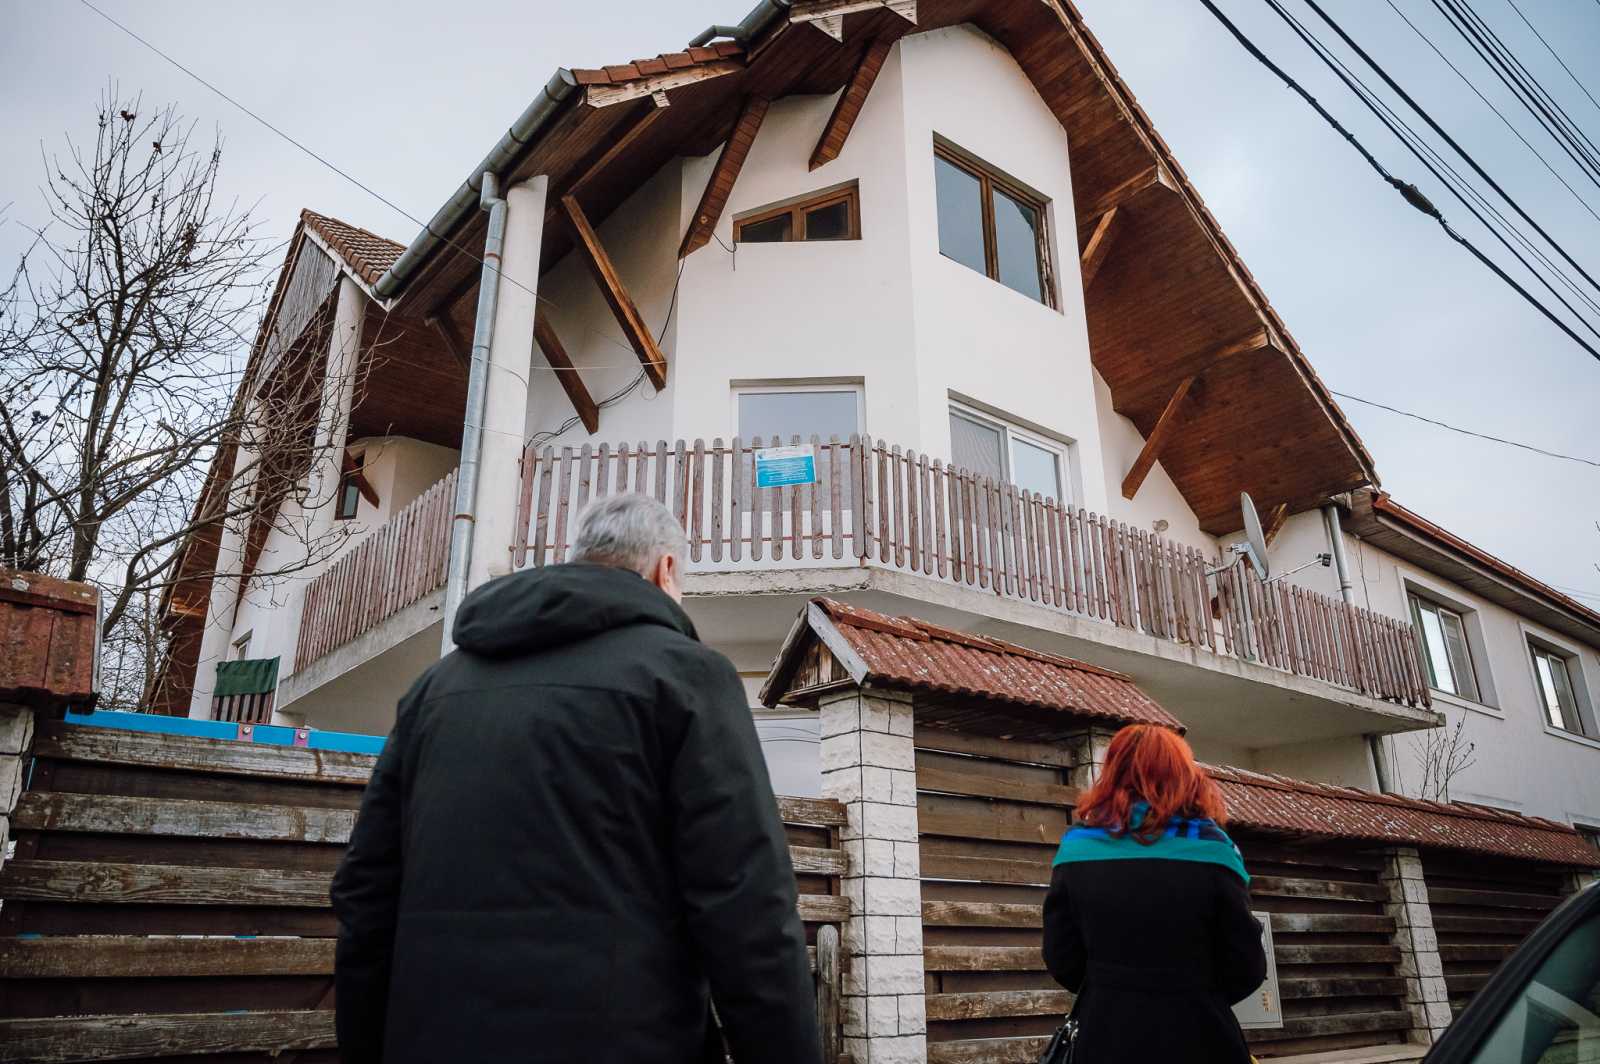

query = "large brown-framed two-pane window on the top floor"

[{"left": 933, "top": 146, "right": 1054, "bottom": 306}]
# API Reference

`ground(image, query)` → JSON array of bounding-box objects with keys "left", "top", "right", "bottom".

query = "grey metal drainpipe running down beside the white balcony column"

[{"left": 443, "top": 170, "right": 506, "bottom": 654}]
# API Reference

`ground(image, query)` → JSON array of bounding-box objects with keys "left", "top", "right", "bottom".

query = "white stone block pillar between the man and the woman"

[{"left": 819, "top": 688, "right": 928, "bottom": 1064}]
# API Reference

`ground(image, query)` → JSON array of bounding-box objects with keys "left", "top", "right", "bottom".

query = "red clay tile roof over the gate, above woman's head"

[{"left": 814, "top": 598, "right": 1182, "bottom": 731}]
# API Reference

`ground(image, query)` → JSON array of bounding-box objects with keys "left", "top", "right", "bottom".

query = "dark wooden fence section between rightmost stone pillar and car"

[{"left": 1422, "top": 853, "right": 1565, "bottom": 1013}]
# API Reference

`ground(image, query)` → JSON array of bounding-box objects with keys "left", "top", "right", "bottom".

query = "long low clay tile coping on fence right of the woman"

[{"left": 1208, "top": 766, "right": 1600, "bottom": 867}]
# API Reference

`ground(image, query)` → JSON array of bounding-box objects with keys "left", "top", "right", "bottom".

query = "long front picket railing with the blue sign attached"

[{"left": 512, "top": 437, "right": 1430, "bottom": 706}]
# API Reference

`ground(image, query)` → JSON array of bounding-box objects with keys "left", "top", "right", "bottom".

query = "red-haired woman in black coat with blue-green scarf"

[{"left": 1045, "top": 725, "right": 1267, "bottom": 1064}]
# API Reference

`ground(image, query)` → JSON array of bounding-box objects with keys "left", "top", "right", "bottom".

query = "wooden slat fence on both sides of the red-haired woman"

[{"left": 917, "top": 728, "right": 1411, "bottom": 1064}]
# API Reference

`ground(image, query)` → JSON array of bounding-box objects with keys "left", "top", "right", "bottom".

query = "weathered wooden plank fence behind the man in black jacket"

[{"left": 0, "top": 723, "right": 850, "bottom": 1064}]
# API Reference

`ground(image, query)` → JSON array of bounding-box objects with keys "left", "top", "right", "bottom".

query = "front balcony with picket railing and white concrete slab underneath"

[{"left": 512, "top": 437, "right": 1435, "bottom": 746}]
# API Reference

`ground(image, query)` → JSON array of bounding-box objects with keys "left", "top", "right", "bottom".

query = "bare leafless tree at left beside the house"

[{"left": 0, "top": 91, "right": 358, "bottom": 704}]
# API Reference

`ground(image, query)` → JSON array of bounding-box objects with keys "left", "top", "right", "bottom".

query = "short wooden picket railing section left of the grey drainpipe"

[{"left": 294, "top": 470, "right": 456, "bottom": 667}]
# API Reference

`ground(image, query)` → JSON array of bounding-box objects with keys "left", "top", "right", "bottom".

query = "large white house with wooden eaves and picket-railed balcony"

[{"left": 160, "top": 0, "right": 1600, "bottom": 827}]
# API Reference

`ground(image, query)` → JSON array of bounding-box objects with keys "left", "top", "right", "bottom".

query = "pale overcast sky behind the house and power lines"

[{"left": 0, "top": 0, "right": 1600, "bottom": 606}]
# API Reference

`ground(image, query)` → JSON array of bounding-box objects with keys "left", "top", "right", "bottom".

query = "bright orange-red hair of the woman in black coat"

[{"left": 1077, "top": 725, "right": 1227, "bottom": 843}]
